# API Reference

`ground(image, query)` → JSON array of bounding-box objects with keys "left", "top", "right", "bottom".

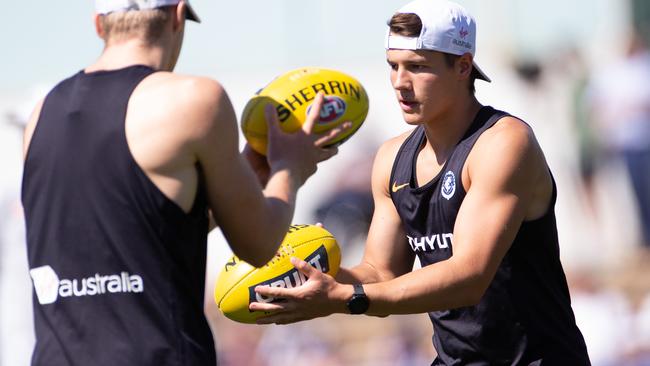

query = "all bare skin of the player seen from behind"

[{"left": 24, "top": 1, "right": 350, "bottom": 265}]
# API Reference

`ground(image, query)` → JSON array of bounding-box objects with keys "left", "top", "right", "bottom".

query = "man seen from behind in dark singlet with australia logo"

[{"left": 22, "top": 0, "right": 344, "bottom": 366}]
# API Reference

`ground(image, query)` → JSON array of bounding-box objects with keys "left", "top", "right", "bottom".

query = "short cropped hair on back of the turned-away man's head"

[{"left": 100, "top": 7, "right": 172, "bottom": 44}]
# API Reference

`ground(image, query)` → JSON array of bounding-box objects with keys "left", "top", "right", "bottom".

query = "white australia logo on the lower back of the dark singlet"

[{"left": 29, "top": 266, "right": 144, "bottom": 305}]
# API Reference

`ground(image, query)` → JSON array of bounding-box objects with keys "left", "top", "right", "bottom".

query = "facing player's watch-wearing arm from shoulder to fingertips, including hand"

[{"left": 251, "top": 118, "right": 551, "bottom": 323}]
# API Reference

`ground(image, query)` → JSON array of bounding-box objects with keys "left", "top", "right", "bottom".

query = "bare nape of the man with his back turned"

[{"left": 85, "top": 39, "right": 171, "bottom": 72}]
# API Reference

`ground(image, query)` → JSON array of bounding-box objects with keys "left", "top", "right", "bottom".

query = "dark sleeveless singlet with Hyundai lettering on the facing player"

[{"left": 389, "top": 107, "right": 589, "bottom": 366}]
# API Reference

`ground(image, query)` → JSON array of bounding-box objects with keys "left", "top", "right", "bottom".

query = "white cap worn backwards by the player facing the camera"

[{"left": 386, "top": 0, "right": 492, "bottom": 82}]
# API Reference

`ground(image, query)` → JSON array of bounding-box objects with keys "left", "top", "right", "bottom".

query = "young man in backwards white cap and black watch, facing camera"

[{"left": 250, "top": 0, "right": 589, "bottom": 365}]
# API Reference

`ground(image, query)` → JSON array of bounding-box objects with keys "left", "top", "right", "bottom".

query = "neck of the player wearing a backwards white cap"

[{"left": 424, "top": 96, "right": 482, "bottom": 161}]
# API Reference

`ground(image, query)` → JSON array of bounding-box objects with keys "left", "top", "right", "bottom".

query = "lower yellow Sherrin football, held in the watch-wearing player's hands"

[{"left": 214, "top": 225, "right": 341, "bottom": 323}]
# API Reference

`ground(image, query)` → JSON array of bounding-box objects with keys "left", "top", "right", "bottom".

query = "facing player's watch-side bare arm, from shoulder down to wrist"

[{"left": 366, "top": 118, "right": 550, "bottom": 315}]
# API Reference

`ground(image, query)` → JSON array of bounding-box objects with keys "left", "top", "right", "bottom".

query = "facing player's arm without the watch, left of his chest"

[{"left": 336, "top": 136, "right": 414, "bottom": 283}]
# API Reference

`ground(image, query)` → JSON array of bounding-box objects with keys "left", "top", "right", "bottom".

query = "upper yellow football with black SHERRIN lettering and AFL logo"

[{"left": 241, "top": 67, "right": 368, "bottom": 155}]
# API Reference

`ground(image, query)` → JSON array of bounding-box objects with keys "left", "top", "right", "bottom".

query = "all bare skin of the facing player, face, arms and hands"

[{"left": 249, "top": 46, "right": 552, "bottom": 324}]
